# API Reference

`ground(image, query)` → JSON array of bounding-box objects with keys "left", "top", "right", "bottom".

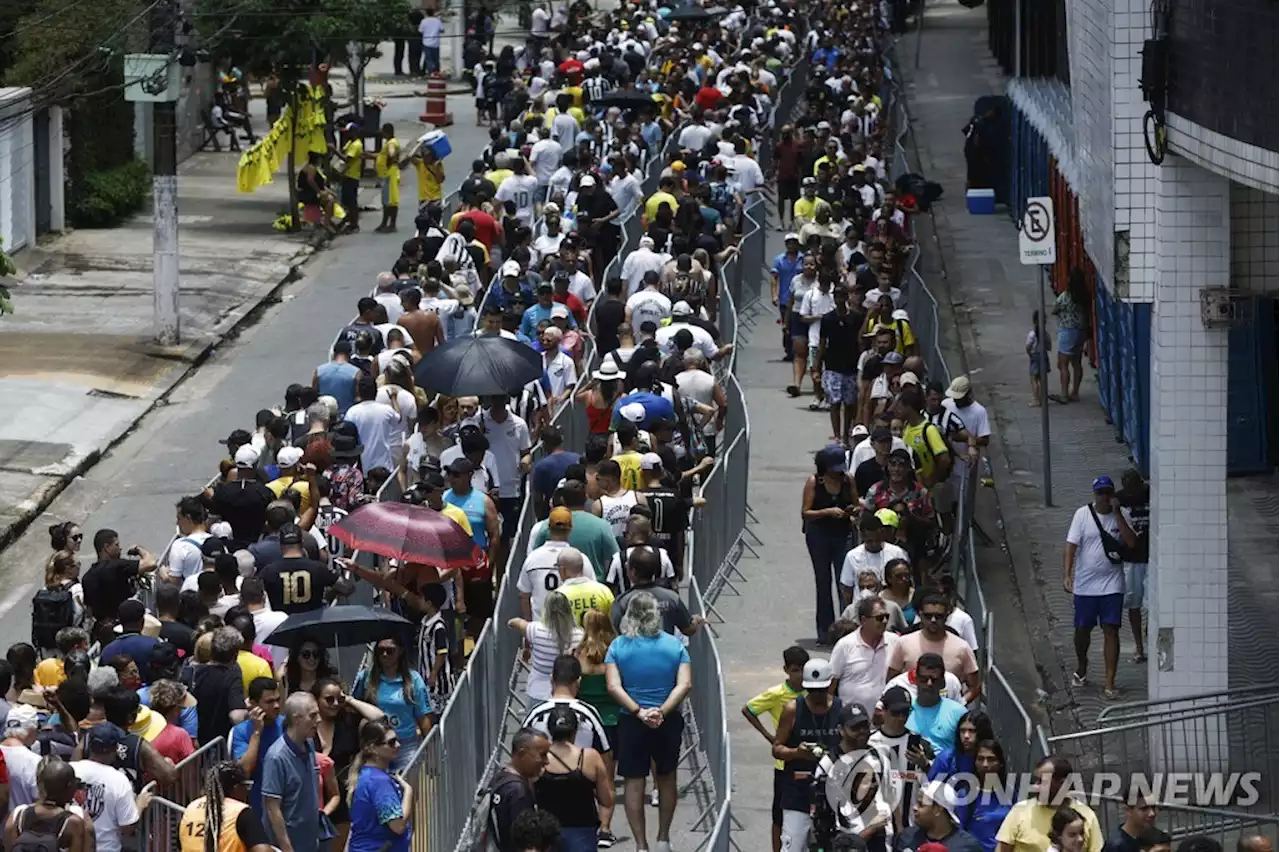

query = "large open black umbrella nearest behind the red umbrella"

[{"left": 413, "top": 334, "right": 543, "bottom": 397}]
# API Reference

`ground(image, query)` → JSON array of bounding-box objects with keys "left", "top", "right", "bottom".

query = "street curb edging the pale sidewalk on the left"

[{"left": 0, "top": 244, "right": 316, "bottom": 553}]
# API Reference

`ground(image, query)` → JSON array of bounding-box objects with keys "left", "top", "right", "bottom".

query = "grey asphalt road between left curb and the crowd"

[{"left": 0, "top": 108, "right": 488, "bottom": 647}]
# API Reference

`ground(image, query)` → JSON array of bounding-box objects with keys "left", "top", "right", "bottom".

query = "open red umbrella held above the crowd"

[{"left": 325, "top": 503, "right": 481, "bottom": 568}]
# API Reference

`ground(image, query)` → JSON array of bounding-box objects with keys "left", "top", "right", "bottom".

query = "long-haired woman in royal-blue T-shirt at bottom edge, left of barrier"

[{"left": 347, "top": 722, "right": 413, "bottom": 852}]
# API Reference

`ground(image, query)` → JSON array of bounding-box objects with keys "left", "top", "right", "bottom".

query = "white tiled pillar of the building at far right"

[{"left": 1147, "top": 155, "right": 1231, "bottom": 768}]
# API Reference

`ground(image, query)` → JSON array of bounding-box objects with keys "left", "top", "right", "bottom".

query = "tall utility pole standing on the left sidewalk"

[{"left": 151, "top": 0, "right": 180, "bottom": 347}]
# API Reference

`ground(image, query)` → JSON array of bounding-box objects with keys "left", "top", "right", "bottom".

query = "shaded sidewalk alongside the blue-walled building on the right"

[{"left": 899, "top": 3, "right": 1147, "bottom": 733}]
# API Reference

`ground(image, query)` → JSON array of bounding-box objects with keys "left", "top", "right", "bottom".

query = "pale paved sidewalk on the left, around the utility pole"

[{"left": 0, "top": 87, "right": 488, "bottom": 549}]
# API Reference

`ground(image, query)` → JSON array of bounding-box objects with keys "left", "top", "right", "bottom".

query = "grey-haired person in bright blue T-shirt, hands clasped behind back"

[{"left": 604, "top": 591, "right": 694, "bottom": 849}]
